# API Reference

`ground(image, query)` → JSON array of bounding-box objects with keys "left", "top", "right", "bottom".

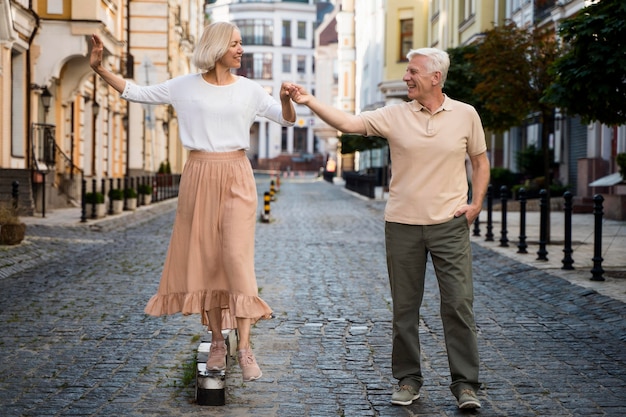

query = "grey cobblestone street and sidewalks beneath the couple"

[{"left": 0, "top": 177, "right": 626, "bottom": 417}]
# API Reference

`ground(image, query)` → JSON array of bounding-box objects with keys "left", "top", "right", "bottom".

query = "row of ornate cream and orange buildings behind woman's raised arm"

[{"left": 0, "top": 0, "right": 204, "bottom": 210}]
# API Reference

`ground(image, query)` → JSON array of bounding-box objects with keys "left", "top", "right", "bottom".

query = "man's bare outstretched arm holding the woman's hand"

[{"left": 289, "top": 84, "right": 366, "bottom": 135}]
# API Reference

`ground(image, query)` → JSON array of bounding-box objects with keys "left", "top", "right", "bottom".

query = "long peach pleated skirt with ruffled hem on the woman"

[{"left": 145, "top": 150, "right": 272, "bottom": 329}]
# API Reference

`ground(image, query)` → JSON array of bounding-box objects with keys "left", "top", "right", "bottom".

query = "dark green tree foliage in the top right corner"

[{"left": 545, "top": 0, "right": 626, "bottom": 126}]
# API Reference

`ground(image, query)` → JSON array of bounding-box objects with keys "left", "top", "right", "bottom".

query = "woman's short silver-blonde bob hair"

[{"left": 192, "top": 22, "right": 239, "bottom": 71}]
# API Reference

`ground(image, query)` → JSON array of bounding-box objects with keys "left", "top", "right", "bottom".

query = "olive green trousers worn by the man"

[{"left": 385, "top": 216, "right": 480, "bottom": 398}]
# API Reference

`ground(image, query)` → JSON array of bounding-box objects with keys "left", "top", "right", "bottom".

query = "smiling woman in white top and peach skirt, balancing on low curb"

[{"left": 90, "top": 22, "right": 296, "bottom": 381}]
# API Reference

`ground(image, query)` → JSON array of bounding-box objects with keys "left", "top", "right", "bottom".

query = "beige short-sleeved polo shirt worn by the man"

[{"left": 359, "top": 96, "right": 487, "bottom": 225}]
